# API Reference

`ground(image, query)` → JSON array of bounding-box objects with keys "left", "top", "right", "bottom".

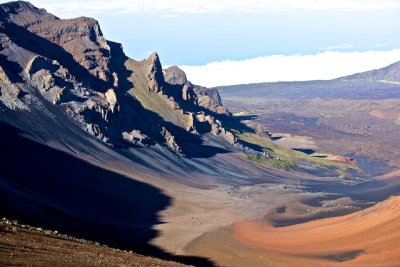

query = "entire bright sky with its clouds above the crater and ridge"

[{"left": 0, "top": 0, "right": 400, "bottom": 87}]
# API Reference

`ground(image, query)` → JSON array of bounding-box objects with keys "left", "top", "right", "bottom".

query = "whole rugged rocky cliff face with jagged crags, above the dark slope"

[{"left": 0, "top": 1, "right": 236, "bottom": 154}]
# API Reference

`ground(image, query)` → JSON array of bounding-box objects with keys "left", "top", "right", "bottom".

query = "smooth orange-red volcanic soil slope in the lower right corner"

[{"left": 233, "top": 196, "right": 400, "bottom": 266}]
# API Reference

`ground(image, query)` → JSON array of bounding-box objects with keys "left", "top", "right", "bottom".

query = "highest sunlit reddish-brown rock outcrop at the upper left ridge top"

[{"left": 0, "top": 1, "right": 113, "bottom": 82}]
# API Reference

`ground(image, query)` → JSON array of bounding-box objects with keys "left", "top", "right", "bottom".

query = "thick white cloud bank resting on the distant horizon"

[{"left": 180, "top": 49, "right": 400, "bottom": 87}]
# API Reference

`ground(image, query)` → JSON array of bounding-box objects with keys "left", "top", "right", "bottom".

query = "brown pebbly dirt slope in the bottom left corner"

[{"left": 0, "top": 220, "right": 187, "bottom": 267}]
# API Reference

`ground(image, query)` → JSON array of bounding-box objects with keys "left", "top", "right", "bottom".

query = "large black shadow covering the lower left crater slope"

[{"left": 0, "top": 122, "right": 213, "bottom": 266}]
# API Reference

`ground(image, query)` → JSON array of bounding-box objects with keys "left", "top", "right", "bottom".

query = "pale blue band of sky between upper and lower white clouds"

[{"left": 100, "top": 11, "right": 400, "bottom": 65}]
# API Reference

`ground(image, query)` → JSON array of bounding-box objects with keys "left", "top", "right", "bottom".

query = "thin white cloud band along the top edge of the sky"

[{"left": 21, "top": 0, "right": 400, "bottom": 17}]
